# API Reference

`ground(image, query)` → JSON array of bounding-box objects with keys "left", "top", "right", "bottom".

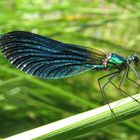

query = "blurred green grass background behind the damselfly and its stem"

[{"left": 0, "top": 0, "right": 140, "bottom": 140}]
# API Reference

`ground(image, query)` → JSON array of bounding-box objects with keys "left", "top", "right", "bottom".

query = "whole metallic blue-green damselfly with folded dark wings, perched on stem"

[{"left": 0, "top": 31, "right": 140, "bottom": 109}]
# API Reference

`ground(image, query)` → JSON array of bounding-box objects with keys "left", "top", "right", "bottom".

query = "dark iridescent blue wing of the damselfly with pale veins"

[{"left": 0, "top": 31, "right": 106, "bottom": 79}]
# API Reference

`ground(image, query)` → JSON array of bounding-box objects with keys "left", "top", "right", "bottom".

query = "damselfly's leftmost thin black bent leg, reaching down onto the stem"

[{"left": 98, "top": 71, "right": 120, "bottom": 116}]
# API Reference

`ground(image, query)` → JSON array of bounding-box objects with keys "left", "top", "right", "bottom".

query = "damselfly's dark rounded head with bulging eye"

[{"left": 128, "top": 54, "right": 140, "bottom": 66}]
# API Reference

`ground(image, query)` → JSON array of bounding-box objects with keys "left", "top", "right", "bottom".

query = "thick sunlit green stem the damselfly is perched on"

[{"left": 5, "top": 93, "right": 140, "bottom": 140}]
